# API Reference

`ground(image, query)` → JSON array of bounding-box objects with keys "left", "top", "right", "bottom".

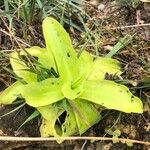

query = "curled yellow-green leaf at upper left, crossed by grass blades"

[{"left": 10, "top": 46, "right": 55, "bottom": 83}]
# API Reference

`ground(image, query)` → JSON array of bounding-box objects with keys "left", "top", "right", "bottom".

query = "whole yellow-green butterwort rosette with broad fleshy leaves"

[{"left": 0, "top": 17, "right": 143, "bottom": 142}]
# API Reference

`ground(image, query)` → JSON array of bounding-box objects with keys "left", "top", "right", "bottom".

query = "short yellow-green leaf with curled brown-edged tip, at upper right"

[{"left": 88, "top": 57, "right": 122, "bottom": 80}]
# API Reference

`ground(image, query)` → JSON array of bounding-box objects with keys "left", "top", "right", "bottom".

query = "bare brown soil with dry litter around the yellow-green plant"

[{"left": 0, "top": 1, "right": 150, "bottom": 150}]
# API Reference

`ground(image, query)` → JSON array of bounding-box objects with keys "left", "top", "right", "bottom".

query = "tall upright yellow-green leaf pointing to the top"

[{"left": 43, "top": 17, "right": 77, "bottom": 81}]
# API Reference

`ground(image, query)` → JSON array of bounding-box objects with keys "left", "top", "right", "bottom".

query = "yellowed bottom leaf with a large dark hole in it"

[{"left": 37, "top": 103, "right": 78, "bottom": 143}]
